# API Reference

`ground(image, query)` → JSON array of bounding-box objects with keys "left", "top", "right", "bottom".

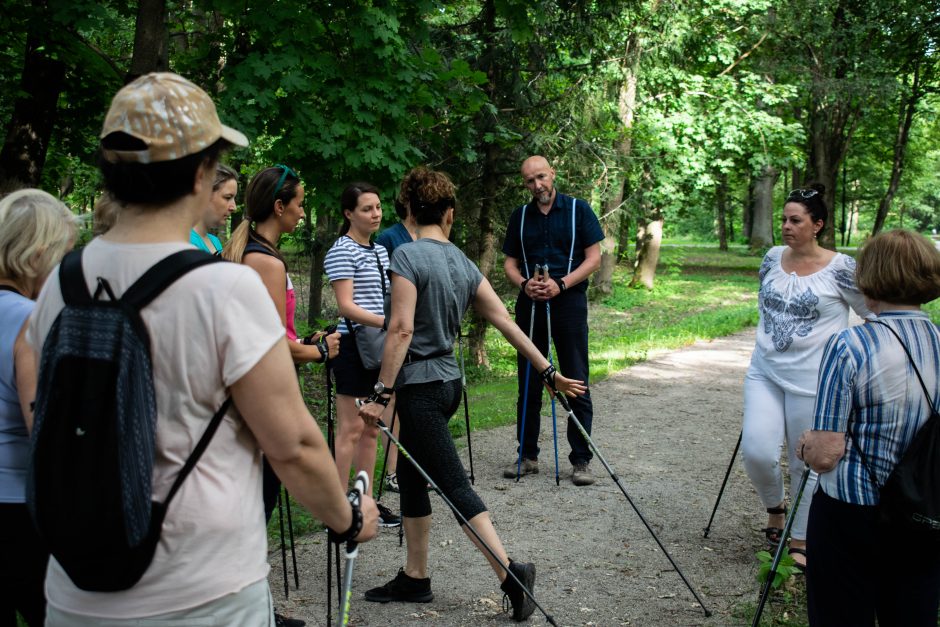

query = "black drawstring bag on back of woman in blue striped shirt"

[{"left": 852, "top": 320, "right": 940, "bottom": 543}]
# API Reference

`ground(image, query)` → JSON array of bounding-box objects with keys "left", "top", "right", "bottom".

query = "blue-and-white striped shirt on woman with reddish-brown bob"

[{"left": 813, "top": 311, "right": 940, "bottom": 505}]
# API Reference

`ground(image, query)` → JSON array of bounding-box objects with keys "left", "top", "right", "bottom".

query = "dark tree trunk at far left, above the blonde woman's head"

[{"left": 0, "top": 29, "right": 65, "bottom": 192}]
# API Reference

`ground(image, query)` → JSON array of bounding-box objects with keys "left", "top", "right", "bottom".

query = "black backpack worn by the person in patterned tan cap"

[{"left": 26, "top": 250, "right": 231, "bottom": 592}]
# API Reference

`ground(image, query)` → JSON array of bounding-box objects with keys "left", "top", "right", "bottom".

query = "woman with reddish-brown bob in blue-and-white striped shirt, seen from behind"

[{"left": 797, "top": 230, "right": 940, "bottom": 627}]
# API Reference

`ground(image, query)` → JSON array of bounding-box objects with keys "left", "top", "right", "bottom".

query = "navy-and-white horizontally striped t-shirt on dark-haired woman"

[{"left": 323, "top": 235, "right": 388, "bottom": 334}]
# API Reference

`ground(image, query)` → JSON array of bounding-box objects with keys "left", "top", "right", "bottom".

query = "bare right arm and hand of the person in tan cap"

[{"left": 232, "top": 341, "right": 378, "bottom": 542}]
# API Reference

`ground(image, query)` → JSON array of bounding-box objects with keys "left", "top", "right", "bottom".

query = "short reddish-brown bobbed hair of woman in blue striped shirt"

[{"left": 855, "top": 229, "right": 940, "bottom": 305}]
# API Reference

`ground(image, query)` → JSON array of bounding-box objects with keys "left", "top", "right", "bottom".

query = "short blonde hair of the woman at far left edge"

[{"left": 0, "top": 189, "right": 79, "bottom": 285}]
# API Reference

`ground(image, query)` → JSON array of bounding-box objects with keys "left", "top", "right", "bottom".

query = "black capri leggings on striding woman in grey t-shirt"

[{"left": 395, "top": 379, "right": 486, "bottom": 524}]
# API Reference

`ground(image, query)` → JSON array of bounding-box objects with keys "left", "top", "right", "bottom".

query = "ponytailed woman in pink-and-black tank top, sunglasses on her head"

[{"left": 222, "top": 165, "right": 339, "bottom": 627}]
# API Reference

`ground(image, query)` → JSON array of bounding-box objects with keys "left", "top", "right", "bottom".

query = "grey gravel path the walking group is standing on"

[{"left": 270, "top": 330, "right": 766, "bottom": 626}]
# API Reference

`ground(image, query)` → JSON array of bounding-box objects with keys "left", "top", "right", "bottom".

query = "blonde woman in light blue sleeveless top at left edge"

[{"left": 0, "top": 189, "right": 78, "bottom": 625}]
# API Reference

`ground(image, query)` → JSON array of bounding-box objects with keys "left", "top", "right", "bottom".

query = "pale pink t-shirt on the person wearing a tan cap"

[{"left": 27, "top": 238, "right": 284, "bottom": 619}]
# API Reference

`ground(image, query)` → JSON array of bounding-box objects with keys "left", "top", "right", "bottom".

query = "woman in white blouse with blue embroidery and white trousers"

[{"left": 741, "top": 184, "right": 870, "bottom": 570}]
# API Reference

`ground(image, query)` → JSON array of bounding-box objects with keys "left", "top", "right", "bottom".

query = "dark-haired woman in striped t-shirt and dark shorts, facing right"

[{"left": 323, "top": 182, "right": 401, "bottom": 527}]
